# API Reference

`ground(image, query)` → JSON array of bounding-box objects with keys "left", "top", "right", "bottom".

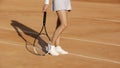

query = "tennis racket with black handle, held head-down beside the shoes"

[{"left": 27, "top": 12, "right": 50, "bottom": 56}]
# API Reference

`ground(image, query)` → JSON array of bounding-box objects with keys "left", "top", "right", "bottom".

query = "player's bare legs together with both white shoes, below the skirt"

[{"left": 48, "top": 10, "right": 68, "bottom": 56}]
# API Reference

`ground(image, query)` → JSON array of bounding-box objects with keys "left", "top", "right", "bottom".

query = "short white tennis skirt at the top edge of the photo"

[{"left": 52, "top": 0, "right": 71, "bottom": 11}]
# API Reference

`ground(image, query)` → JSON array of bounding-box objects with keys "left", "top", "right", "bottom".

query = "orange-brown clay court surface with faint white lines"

[{"left": 0, "top": 0, "right": 120, "bottom": 68}]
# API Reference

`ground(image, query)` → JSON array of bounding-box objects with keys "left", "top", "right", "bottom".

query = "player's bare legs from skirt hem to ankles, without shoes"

[{"left": 52, "top": 10, "right": 67, "bottom": 45}]
